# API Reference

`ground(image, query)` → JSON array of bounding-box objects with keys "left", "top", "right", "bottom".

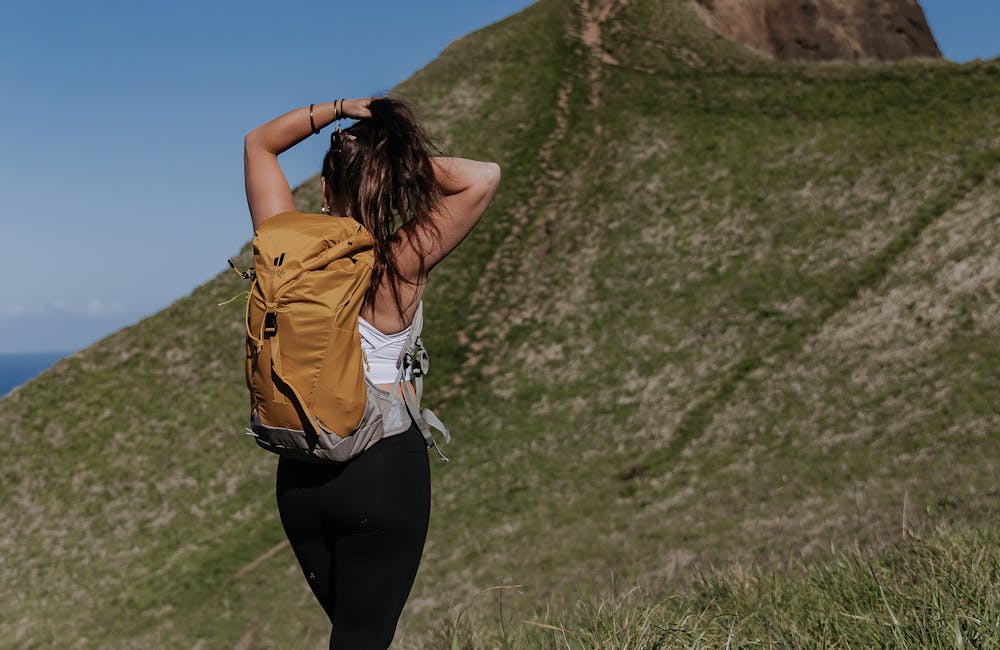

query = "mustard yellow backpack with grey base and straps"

[{"left": 230, "top": 212, "right": 451, "bottom": 462}]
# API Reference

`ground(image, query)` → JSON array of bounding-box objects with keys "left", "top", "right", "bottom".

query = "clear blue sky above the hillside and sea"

[{"left": 0, "top": 0, "right": 1000, "bottom": 353}]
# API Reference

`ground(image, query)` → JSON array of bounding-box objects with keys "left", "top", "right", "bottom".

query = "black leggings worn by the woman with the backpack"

[{"left": 276, "top": 418, "right": 431, "bottom": 650}]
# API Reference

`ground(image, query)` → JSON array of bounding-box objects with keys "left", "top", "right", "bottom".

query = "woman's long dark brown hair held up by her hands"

[{"left": 322, "top": 98, "right": 440, "bottom": 315}]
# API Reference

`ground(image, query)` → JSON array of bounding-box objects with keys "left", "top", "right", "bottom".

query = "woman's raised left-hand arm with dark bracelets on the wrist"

[{"left": 243, "top": 98, "right": 371, "bottom": 230}]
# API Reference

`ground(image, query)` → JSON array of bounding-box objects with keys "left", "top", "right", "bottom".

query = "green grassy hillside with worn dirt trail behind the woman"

[{"left": 0, "top": 0, "right": 1000, "bottom": 649}]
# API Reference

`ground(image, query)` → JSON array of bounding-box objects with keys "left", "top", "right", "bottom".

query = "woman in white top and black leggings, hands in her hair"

[{"left": 244, "top": 93, "right": 500, "bottom": 650}]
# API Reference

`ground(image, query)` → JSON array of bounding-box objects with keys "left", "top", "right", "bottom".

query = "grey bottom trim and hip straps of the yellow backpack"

[{"left": 245, "top": 301, "right": 451, "bottom": 463}]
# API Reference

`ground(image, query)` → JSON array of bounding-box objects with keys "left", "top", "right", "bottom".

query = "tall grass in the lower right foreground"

[{"left": 441, "top": 528, "right": 1000, "bottom": 650}]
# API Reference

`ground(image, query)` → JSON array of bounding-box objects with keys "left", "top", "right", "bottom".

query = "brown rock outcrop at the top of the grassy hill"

[{"left": 695, "top": 0, "right": 941, "bottom": 61}]
